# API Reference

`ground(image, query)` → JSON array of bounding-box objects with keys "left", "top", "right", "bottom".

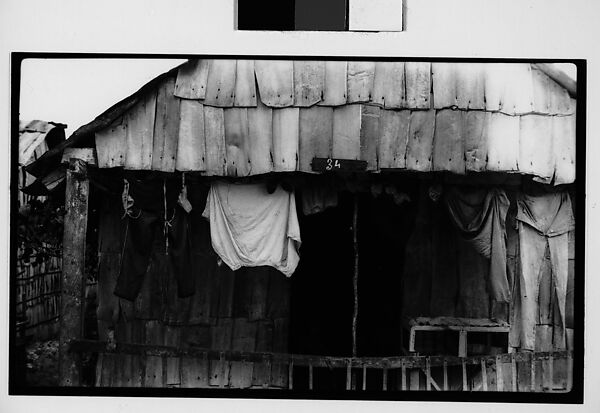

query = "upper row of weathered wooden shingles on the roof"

[{"left": 170, "top": 59, "right": 574, "bottom": 115}]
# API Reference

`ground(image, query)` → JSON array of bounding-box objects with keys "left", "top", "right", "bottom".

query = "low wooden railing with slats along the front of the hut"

[{"left": 70, "top": 340, "right": 573, "bottom": 392}]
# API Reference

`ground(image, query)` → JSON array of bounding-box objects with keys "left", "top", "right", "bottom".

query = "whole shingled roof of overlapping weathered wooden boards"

[{"left": 96, "top": 60, "right": 576, "bottom": 184}]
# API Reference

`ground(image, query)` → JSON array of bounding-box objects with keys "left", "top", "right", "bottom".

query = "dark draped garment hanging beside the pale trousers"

[{"left": 445, "top": 187, "right": 510, "bottom": 302}]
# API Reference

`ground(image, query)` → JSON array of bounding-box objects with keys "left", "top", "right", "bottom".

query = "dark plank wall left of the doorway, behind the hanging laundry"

[{"left": 96, "top": 199, "right": 290, "bottom": 388}]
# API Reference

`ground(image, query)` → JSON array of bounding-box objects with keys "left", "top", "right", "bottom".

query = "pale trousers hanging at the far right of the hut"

[{"left": 510, "top": 190, "right": 575, "bottom": 350}]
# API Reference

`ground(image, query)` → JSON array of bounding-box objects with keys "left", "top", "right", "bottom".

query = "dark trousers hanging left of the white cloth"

[{"left": 114, "top": 175, "right": 195, "bottom": 301}]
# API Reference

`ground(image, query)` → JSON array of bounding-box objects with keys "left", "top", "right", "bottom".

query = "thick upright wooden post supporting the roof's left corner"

[{"left": 58, "top": 159, "right": 90, "bottom": 386}]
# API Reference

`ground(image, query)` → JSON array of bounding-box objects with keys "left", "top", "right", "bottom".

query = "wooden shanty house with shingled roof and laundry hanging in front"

[{"left": 22, "top": 59, "right": 576, "bottom": 392}]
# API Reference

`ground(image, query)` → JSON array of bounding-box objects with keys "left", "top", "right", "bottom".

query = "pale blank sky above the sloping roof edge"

[{"left": 19, "top": 59, "right": 185, "bottom": 137}]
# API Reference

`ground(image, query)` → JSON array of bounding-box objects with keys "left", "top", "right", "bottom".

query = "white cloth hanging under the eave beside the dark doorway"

[{"left": 202, "top": 181, "right": 301, "bottom": 277}]
